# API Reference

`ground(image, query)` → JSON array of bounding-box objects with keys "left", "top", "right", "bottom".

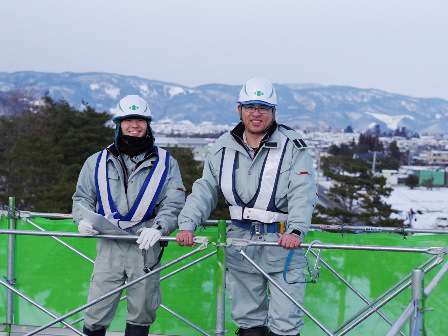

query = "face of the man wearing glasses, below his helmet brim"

[{"left": 238, "top": 104, "right": 274, "bottom": 134}]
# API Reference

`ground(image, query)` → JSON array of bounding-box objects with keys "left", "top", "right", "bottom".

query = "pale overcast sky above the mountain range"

[{"left": 0, "top": 0, "right": 448, "bottom": 99}]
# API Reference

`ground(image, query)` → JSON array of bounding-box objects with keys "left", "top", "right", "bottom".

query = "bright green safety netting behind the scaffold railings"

[{"left": 0, "top": 217, "right": 448, "bottom": 336}]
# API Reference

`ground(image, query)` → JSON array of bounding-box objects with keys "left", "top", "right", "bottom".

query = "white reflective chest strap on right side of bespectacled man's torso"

[{"left": 253, "top": 136, "right": 287, "bottom": 209}]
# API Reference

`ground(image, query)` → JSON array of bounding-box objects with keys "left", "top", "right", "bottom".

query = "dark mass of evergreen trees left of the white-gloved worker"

[{"left": 0, "top": 97, "right": 113, "bottom": 213}]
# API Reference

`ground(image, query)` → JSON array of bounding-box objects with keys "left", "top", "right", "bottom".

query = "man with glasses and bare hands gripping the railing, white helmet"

[{"left": 176, "top": 78, "right": 317, "bottom": 336}]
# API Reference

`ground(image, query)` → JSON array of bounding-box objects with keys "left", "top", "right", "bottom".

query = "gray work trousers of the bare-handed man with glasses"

[{"left": 228, "top": 267, "right": 305, "bottom": 335}]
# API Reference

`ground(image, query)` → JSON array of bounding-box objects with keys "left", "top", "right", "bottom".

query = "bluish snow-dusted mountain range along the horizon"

[{"left": 0, "top": 71, "right": 448, "bottom": 133}]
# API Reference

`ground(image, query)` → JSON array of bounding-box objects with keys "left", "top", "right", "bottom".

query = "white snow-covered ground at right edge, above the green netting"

[{"left": 386, "top": 186, "right": 448, "bottom": 229}]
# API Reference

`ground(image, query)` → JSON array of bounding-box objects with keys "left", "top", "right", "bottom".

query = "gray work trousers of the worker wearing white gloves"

[{"left": 85, "top": 239, "right": 160, "bottom": 330}]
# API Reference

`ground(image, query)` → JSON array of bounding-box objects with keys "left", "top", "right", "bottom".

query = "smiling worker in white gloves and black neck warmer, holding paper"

[{"left": 73, "top": 95, "right": 185, "bottom": 336}]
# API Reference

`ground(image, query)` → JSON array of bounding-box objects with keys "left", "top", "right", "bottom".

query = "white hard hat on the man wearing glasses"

[{"left": 238, "top": 77, "right": 277, "bottom": 107}]
